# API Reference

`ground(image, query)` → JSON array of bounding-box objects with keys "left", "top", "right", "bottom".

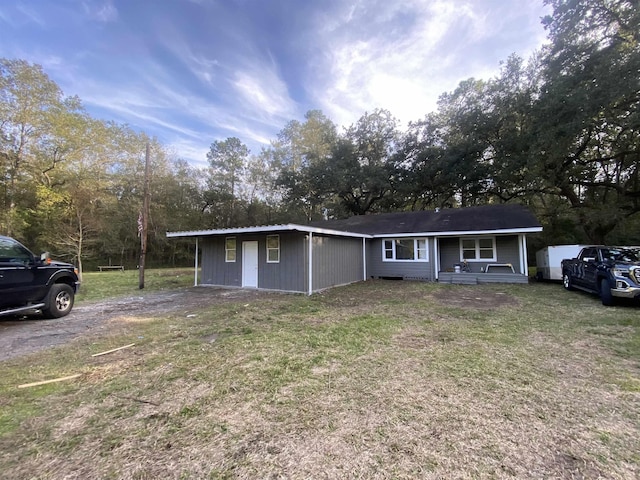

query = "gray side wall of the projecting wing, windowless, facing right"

[{"left": 312, "top": 235, "right": 364, "bottom": 291}]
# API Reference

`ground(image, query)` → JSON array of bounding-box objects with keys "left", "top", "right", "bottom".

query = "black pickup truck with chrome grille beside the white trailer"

[{"left": 562, "top": 246, "right": 640, "bottom": 305}]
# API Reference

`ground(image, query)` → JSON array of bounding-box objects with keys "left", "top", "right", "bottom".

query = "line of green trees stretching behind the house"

[{"left": 0, "top": 0, "right": 640, "bottom": 278}]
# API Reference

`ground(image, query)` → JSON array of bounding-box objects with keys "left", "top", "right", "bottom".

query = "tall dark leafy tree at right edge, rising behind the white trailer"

[{"left": 535, "top": 0, "right": 640, "bottom": 243}]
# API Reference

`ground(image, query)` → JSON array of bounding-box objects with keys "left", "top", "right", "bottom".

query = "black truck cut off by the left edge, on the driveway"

[{"left": 0, "top": 236, "right": 80, "bottom": 318}]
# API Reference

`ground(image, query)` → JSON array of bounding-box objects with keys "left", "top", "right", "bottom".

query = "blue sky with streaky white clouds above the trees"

[{"left": 0, "top": 0, "right": 549, "bottom": 166}]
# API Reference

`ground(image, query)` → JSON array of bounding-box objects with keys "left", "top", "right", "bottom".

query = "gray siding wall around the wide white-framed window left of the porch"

[{"left": 367, "top": 238, "right": 434, "bottom": 281}]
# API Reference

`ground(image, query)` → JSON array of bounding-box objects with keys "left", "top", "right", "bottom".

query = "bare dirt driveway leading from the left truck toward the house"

[{"left": 0, "top": 287, "right": 269, "bottom": 362}]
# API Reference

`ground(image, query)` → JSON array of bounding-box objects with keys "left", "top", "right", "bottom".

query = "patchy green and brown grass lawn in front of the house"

[{"left": 0, "top": 280, "right": 640, "bottom": 480}]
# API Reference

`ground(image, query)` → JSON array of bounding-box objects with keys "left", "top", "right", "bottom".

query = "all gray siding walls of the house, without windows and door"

[{"left": 200, "top": 232, "right": 522, "bottom": 293}]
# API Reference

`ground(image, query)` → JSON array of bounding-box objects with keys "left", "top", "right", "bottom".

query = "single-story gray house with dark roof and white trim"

[{"left": 174, "top": 205, "right": 542, "bottom": 293}]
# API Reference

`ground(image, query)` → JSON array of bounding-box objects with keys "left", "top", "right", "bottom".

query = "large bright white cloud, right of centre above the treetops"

[{"left": 310, "top": 0, "right": 544, "bottom": 129}]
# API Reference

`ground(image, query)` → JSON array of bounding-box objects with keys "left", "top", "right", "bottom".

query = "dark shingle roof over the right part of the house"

[{"left": 310, "top": 204, "right": 541, "bottom": 235}]
